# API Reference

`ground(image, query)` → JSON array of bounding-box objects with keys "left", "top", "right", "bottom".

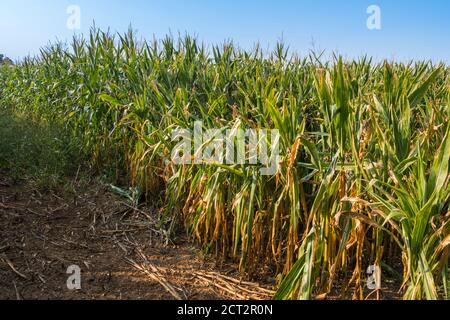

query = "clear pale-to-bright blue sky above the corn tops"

[{"left": 0, "top": 0, "right": 450, "bottom": 63}]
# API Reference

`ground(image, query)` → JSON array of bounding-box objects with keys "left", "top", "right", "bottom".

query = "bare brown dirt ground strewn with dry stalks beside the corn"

[{"left": 0, "top": 172, "right": 273, "bottom": 300}]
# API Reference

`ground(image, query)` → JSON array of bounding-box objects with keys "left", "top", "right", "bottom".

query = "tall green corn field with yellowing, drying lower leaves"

[{"left": 0, "top": 29, "right": 450, "bottom": 299}]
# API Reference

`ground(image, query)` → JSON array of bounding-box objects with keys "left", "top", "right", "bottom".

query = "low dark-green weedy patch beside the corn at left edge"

[{"left": 0, "top": 110, "right": 85, "bottom": 188}]
